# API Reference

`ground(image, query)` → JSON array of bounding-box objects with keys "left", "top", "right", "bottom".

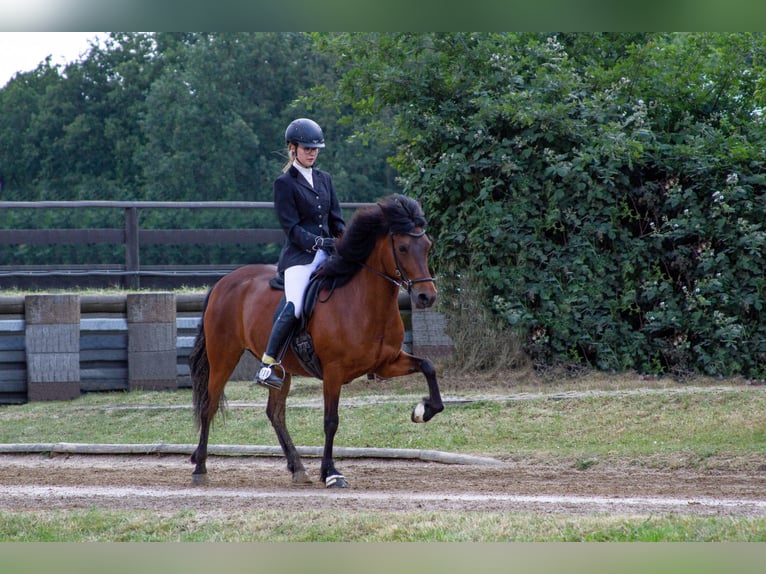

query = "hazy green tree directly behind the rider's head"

[{"left": 141, "top": 33, "right": 402, "bottom": 206}]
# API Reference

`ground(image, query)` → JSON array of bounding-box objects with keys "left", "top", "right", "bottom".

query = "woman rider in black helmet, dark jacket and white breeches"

[{"left": 255, "top": 118, "right": 345, "bottom": 389}]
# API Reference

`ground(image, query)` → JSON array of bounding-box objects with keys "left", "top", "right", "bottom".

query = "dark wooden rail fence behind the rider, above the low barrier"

[{"left": 0, "top": 201, "right": 370, "bottom": 289}]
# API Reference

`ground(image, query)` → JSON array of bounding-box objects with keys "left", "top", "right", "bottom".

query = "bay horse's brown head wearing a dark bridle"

[{"left": 390, "top": 227, "right": 436, "bottom": 309}]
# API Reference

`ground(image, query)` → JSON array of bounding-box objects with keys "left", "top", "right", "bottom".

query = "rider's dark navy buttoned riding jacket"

[{"left": 274, "top": 166, "right": 346, "bottom": 272}]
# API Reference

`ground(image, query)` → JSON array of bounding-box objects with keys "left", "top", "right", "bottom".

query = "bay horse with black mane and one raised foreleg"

[{"left": 189, "top": 194, "right": 444, "bottom": 488}]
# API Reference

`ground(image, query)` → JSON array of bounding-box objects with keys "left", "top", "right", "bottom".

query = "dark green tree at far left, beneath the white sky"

[{"left": 0, "top": 34, "right": 155, "bottom": 199}]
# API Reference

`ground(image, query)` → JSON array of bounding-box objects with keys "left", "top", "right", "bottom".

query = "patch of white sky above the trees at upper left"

[{"left": 0, "top": 32, "right": 106, "bottom": 88}]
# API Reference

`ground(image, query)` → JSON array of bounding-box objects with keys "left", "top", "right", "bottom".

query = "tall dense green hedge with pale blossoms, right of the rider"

[{"left": 322, "top": 34, "right": 766, "bottom": 377}]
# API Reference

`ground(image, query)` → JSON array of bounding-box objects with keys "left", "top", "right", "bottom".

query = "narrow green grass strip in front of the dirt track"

[{"left": 0, "top": 508, "right": 766, "bottom": 542}]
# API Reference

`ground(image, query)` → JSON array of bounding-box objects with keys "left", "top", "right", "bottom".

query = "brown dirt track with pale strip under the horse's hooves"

[{"left": 0, "top": 454, "right": 766, "bottom": 517}]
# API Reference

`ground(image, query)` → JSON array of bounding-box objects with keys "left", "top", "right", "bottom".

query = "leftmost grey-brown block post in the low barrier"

[{"left": 24, "top": 295, "right": 80, "bottom": 401}]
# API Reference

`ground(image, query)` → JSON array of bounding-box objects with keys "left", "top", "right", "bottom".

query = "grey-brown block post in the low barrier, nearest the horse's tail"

[{"left": 127, "top": 293, "right": 178, "bottom": 390}]
